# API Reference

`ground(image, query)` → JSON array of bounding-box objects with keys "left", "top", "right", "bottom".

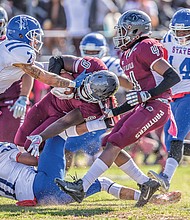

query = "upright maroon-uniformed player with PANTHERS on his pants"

[{"left": 56, "top": 10, "right": 180, "bottom": 207}]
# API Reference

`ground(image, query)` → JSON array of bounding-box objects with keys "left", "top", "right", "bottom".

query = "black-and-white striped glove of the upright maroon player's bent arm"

[{"left": 126, "top": 91, "right": 151, "bottom": 106}]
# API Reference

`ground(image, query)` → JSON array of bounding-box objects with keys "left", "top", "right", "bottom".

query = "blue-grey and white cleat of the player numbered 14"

[{"left": 148, "top": 170, "right": 170, "bottom": 193}]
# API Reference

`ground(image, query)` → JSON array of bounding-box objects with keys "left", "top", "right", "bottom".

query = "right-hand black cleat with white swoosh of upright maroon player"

[{"left": 135, "top": 179, "right": 160, "bottom": 207}]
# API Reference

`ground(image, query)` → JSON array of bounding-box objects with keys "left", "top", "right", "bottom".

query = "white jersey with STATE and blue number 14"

[{"left": 162, "top": 31, "right": 190, "bottom": 95}]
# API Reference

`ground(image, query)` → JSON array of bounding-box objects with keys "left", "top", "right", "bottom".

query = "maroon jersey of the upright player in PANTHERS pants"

[{"left": 120, "top": 38, "right": 171, "bottom": 98}]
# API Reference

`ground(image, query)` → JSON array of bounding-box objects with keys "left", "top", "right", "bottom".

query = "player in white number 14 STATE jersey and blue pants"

[{"left": 149, "top": 8, "right": 190, "bottom": 192}]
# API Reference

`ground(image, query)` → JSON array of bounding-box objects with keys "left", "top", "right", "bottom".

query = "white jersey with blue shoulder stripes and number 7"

[{"left": 0, "top": 40, "right": 36, "bottom": 93}]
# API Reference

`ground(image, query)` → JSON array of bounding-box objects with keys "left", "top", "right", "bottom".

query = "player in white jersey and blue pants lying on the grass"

[{"left": 0, "top": 137, "right": 181, "bottom": 206}]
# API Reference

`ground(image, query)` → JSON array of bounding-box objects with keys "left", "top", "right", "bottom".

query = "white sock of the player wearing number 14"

[{"left": 163, "top": 157, "right": 179, "bottom": 182}]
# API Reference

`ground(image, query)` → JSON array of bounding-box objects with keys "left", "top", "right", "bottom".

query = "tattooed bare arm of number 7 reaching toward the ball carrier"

[{"left": 13, "top": 63, "right": 76, "bottom": 88}]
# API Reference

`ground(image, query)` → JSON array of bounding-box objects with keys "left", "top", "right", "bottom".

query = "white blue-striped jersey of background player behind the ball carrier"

[{"left": 101, "top": 56, "right": 125, "bottom": 77}]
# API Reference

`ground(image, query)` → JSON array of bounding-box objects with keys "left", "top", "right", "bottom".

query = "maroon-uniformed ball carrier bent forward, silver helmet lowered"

[{"left": 15, "top": 55, "right": 119, "bottom": 154}]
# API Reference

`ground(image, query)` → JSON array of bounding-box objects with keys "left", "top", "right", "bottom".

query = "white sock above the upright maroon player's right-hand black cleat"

[{"left": 119, "top": 159, "right": 149, "bottom": 184}]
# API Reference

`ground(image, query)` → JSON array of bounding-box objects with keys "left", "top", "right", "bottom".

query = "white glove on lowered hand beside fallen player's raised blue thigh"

[{"left": 27, "top": 135, "right": 42, "bottom": 157}]
